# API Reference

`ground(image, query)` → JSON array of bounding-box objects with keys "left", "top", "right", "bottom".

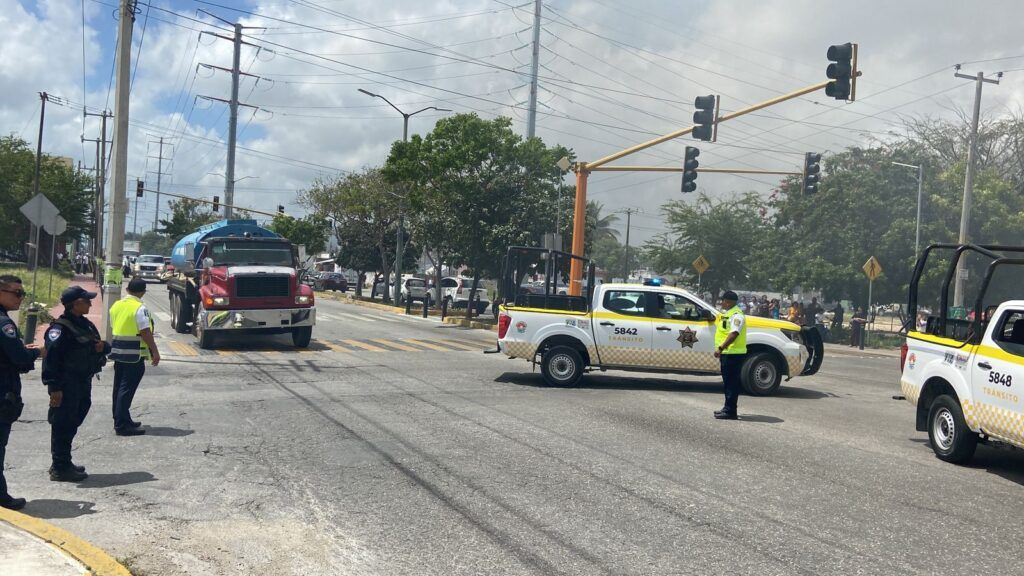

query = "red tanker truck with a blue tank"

[{"left": 167, "top": 220, "right": 316, "bottom": 348}]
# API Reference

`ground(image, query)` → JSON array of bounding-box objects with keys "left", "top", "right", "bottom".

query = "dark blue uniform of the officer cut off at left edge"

[{"left": 0, "top": 306, "right": 39, "bottom": 503}]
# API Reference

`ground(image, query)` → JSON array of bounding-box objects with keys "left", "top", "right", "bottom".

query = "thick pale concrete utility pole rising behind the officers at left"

[{"left": 103, "top": 0, "right": 135, "bottom": 339}]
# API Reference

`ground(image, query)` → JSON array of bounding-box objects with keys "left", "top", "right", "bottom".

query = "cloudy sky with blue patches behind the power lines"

[{"left": 0, "top": 0, "right": 1024, "bottom": 243}]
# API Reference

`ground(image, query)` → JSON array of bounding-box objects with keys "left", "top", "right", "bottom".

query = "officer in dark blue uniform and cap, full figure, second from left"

[{"left": 43, "top": 286, "right": 111, "bottom": 482}]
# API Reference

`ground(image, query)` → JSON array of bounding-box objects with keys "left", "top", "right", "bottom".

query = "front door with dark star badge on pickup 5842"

[{"left": 650, "top": 292, "right": 721, "bottom": 373}]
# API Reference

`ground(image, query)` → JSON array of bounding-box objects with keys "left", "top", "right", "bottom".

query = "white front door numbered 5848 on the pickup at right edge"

[{"left": 970, "top": 308, "right": 1024, "bottom": 443}]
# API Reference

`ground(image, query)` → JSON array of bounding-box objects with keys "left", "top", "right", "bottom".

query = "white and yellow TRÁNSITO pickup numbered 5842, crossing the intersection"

[{"left": 498, "top": 276, "right": 822, "bottom": 389}]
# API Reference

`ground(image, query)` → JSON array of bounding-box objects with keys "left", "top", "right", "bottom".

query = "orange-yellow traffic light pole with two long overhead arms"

[{"left": 568, "top": 79, "right": 835, "bottom": 296}]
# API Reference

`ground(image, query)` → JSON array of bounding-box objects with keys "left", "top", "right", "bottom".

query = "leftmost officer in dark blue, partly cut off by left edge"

[{"left": 0, "top": 275, "right": 45, "bottom": 510}]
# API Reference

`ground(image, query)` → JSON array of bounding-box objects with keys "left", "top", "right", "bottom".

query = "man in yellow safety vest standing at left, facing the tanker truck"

[{"left": 110, "top": 278, "right": 160, "bottom": 436}]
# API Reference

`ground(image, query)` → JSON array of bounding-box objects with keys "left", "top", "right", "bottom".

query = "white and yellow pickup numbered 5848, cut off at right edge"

[{"left": 900, "top": 244, "right": 1024, "bottom": 463}]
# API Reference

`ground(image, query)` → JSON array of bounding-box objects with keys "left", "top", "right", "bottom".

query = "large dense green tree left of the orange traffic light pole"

[{"left": 384, "top": 114, "right": 569, "bottom": 310}]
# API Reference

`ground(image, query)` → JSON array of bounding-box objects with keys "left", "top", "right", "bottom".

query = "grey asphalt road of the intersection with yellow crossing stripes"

[{"left": 7, "top": 285, "right": 1024, "bottom": 575}]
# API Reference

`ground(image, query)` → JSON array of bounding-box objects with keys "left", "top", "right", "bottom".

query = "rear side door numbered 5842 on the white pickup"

[{"left": 593, "top": 290, "right": 653, "bottom": 367}]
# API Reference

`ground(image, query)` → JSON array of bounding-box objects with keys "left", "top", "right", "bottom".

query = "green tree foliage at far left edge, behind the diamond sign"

[{"left": 0, "top": 135, "right": 95, "bottom": 253}]
